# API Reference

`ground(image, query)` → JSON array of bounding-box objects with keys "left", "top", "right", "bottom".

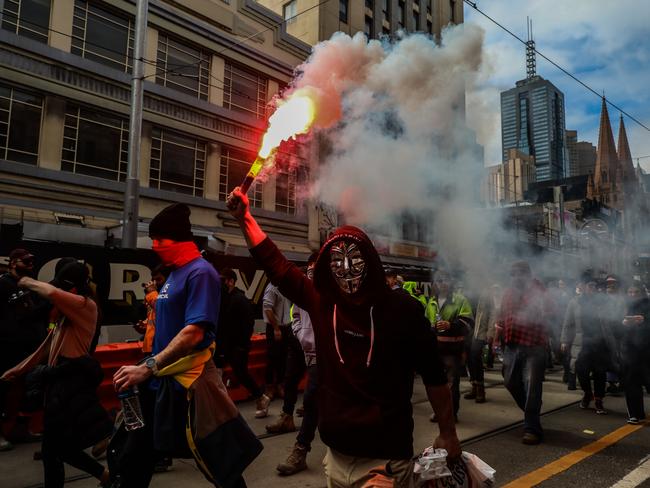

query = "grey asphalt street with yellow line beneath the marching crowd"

[{"left": 0, "top": 370, "right": 650, "bottom": 488}]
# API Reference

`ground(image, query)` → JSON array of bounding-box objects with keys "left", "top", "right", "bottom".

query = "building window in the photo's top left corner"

[{"left": 2, "top": 0, "right": 50, "bottom": 44}]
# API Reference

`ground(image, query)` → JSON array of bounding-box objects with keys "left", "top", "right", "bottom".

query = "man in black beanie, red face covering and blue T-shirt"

[{"left": 111, "top": 203, "right": 262, "bottom": 488}]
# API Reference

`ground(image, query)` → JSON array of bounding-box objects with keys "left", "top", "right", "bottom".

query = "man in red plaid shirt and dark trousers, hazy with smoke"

[{"left": 499, "top": 261, "right": 549, "bottom": 444}]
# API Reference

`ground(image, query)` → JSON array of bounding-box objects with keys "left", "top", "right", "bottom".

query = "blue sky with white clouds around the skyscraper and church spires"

[{"left": 465, "top": 0, "right": 650, "bottom": 171}]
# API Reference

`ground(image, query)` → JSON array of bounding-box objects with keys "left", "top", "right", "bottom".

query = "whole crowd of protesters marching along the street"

[{"left": 0, "top": 197, "right": 650, "bottom": 488}]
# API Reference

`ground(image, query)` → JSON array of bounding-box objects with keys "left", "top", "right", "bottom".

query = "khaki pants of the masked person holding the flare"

[{"left": 323, "top": 448, "right": 415, "bottom": 488}]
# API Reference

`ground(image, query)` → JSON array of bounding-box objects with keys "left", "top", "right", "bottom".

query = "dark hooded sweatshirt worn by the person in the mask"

[{"left": 251, "top": 226, "right": 447, "bottom": 459}]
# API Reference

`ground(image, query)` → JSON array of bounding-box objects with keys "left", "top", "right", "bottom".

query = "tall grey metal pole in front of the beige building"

[{"left": 122, "top": 0, "right": 149, "bottom": 248}]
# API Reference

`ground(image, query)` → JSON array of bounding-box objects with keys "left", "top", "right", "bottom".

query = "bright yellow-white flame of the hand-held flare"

[{"left": 259, "top": 90, "right": 316, "bottom": 159}]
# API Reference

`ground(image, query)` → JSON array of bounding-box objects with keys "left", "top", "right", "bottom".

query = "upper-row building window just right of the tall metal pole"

[{"left": 156, "top": 32, "right": 210, "bottom": 100}]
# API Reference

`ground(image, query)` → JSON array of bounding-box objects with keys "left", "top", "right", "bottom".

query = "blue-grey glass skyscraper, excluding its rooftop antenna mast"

[{"left": 501, "top": 76, "right": 568, "bottom": 181}]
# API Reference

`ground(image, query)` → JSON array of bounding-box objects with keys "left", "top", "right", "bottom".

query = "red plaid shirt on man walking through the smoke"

[{"left": 499, "top": 280, "right": 550, "bottom": 346}]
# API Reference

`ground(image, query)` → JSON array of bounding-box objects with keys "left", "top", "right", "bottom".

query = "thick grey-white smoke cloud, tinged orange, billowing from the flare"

[{"left": 285, "top": 24, "right": 508, "bottom": 292}]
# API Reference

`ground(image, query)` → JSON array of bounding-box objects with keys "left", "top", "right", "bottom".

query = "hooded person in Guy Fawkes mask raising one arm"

[{"left": 228, "top": 189, "right": 460, "bottom": 488}]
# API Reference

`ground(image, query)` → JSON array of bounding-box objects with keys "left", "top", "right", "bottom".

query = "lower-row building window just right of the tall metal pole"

[{"left": 149, "top": 127, "right": 207, "bottom": 197}]
